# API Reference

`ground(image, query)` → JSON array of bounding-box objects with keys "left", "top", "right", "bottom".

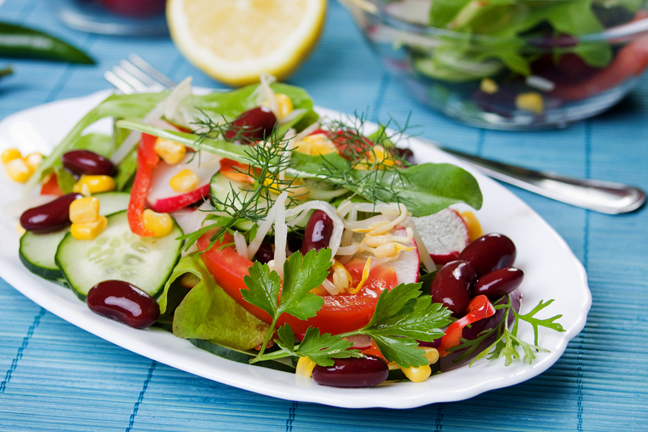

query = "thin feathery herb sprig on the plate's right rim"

[{"left": 448, "top": 297, "right": 565, "bottom": 366}]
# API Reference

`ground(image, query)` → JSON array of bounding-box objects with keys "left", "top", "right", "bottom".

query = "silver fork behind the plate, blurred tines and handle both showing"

[{"left": 104, "top": 54, "right": 646, "bottom": 214}]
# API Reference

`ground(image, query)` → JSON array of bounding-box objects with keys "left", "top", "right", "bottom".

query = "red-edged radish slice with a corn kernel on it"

[{"left": 147, "top": 152, "right": 221, "bottom": 213}]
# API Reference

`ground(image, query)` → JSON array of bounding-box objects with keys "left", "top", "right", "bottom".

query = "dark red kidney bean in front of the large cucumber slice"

[{"left": 86, "top": 280, "right": 160, "bottom": 329}]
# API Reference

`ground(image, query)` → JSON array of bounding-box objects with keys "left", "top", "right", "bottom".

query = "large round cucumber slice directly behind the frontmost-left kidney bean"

[{"left": 55, "top": 211, "right": 183, "bottom": 300}]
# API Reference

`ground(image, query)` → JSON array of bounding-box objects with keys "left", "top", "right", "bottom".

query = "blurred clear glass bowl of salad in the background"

[{"left": 339, "top": 0, "right": 648, "bottom": 130}]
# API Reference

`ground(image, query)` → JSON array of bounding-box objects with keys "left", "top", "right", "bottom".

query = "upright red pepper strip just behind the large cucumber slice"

[{"left": 126, "top": 134, "right": 160, "bottom": 237}]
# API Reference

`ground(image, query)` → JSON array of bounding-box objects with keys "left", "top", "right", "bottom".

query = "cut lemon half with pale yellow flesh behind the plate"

[{"left": 167, "top": 0, "right": 326, "bottom": 86}]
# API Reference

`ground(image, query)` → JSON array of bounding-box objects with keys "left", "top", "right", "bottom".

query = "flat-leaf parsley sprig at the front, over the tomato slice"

[{"left": 241, "top": 249, "right": 450, "bottom": 367}]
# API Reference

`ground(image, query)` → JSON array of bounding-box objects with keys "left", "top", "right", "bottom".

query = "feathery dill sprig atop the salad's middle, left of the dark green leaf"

[{"left": 182, "top": 117, "right": 299, "bottom": 250}]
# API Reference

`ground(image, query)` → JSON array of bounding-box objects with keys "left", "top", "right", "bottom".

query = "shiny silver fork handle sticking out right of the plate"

[{"left": 425, "top": 145, "right": 646, "bottom": 214}]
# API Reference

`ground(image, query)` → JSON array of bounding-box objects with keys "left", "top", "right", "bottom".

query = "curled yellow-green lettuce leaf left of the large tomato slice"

[{"left": 158, "top": 254, "right": 268, "bottom": 350}]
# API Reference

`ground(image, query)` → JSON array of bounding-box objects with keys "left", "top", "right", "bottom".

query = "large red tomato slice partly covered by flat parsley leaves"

[{"left": 197, "top": 231, "right": 398, "bottom": 336}]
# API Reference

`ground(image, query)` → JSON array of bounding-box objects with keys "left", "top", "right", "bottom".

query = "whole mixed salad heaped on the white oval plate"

[{"left": 1, "top": 76, "right": 563, "bottom": 387}]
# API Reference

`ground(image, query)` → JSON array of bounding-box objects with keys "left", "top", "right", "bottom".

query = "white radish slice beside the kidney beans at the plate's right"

[{"left": 412, "top": 209, "right": 469, "bottom": 266}]
